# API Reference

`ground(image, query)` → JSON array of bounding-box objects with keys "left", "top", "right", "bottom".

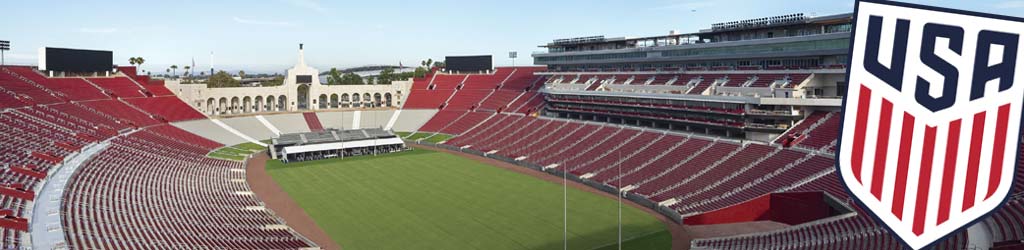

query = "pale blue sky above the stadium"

[{"left": 0, "top": 0, "right": 1024, "bottom": 72}]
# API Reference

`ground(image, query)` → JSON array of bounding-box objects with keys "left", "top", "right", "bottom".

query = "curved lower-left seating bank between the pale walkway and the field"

[{"left": 61, "top": 130, "right": 313, "bottom": 249}]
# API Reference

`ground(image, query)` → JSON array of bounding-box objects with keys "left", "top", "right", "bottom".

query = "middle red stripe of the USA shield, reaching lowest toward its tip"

[{"left": 913, "top": 126, "right": 935, "bottom": 236}]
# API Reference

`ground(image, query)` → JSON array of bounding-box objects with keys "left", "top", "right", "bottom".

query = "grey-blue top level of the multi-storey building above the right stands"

[{"left": 534, "top": 13, "right": 853, "bottom": 66}]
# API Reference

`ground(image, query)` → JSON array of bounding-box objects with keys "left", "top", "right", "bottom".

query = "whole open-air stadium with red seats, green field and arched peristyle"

[{"left": 0, "top": 2, "right": 1024, "bottom": 249}]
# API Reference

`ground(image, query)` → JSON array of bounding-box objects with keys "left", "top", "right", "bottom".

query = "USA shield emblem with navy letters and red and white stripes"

[{"left": 837, "top": 0, "right": 1024, "bottom": 249}]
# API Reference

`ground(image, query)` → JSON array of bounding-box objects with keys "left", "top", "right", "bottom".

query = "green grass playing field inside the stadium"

[{"left": 267, "top": 150, "right": 672, "bottom": 247}]
